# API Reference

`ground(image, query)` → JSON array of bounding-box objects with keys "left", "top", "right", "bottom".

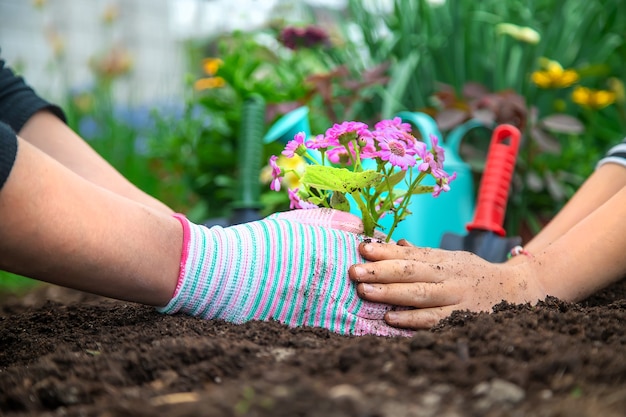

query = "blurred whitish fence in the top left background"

[{"left": 0, "top": 0, "right": 345, "bottom": 105}]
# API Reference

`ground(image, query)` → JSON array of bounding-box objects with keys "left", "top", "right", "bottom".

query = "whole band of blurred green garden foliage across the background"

[{"left": 147, "top": 0, "right": 626, "bottom": 233}]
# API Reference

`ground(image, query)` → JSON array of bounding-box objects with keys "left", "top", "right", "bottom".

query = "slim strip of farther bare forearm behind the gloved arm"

[{"left": 19, "top": 110, "right": 173, "bottom": 214}]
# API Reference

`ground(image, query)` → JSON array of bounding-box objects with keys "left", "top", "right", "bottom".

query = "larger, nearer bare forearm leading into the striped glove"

[{"left": 0, "top": 135, "right": 182, "bottom": 305}]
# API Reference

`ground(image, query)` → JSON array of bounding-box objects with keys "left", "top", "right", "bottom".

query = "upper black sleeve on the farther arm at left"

[{"left": 0, "top": 59, "right": 66, "bottom": 132}]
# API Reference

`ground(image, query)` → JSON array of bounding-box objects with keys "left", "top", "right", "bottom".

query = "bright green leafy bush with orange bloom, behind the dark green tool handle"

[{"left": 151, "top": 32, "right": 312, "bottom": 221}]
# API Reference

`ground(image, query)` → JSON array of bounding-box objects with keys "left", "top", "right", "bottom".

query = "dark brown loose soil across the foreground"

[{"left": 0, "top": 281, "right": 626, "bottom": 417}]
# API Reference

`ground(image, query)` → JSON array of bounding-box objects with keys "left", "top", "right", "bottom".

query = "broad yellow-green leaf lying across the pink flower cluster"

[{"left": 301, "top": 165, "right": 383, "bottom": 194}]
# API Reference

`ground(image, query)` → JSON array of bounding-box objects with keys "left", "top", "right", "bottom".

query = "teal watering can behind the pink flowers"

[{"left": 263, "top": 106, "right": 485, "bottom": 248}]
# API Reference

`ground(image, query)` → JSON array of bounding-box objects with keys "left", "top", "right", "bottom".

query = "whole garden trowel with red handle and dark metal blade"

[{"left": 440, "top": 124, "right": 521, "bottom": 262}]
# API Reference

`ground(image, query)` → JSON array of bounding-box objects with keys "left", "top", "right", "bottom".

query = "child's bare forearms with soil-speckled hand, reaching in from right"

[{"left": 350, "top": 165, "right": 626, "bottom": 328}]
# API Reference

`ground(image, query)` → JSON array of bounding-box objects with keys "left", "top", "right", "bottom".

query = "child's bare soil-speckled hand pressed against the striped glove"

[{"left": 349, "top": 241, "right": 547, "bottom": 329}]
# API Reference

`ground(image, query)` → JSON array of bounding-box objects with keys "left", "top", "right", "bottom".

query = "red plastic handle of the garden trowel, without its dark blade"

[{"left": 467, "top": 124, "right": 520, "bottom": 236}]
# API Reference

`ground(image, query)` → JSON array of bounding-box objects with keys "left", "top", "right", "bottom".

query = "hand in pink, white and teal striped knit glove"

[{"left": 159, "top": 209, "right": 412, "bottom": 336}]
